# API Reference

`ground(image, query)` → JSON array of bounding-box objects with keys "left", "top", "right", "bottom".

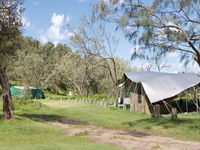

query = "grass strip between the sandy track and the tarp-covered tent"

[{"left": 41, "top": 101, "right": 200, "bottom": 142}]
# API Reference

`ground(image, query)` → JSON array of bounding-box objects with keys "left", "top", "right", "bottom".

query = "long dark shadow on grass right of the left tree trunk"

[{"left": 19, "top": 113, "right": 88, "bottom": 125}]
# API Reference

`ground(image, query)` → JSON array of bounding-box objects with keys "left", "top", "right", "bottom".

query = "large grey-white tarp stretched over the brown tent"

[{"left": 125, "top": 71, "right": 200, "bottom": 103}]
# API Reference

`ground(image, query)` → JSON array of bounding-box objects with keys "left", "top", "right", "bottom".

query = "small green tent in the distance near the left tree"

[{"left": 10, "top": 86, "right": 45, "bottom": 99}]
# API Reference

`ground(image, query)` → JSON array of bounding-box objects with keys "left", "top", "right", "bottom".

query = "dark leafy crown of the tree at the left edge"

[{"left": 0, "top": 0, "right": 23, "bottom": 65}]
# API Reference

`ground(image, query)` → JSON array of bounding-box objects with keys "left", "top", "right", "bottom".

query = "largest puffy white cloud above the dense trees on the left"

[{"left": 40, "top": 13, "right": 73, "bottom": 45}]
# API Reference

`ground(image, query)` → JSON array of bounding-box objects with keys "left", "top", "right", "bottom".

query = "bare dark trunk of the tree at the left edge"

[{"left": 0, "top": 66, "right": 13, "bottom": 120}]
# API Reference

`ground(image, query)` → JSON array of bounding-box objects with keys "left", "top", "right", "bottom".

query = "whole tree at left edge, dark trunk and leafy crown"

[{"left": 0, "top": 0, "right": 23, "bottom": 119}]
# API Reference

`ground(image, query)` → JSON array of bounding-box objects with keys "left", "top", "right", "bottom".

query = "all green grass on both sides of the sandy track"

[{"left": 0, "top": 100, "right": 200, "bottom": 150}]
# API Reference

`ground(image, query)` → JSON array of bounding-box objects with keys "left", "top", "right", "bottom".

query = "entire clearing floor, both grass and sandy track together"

[{"left": 0, "top": 100, "right": 200, "bottom": 150}]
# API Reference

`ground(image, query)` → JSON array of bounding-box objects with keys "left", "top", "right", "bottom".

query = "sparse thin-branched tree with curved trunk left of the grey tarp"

[{"left": 71, "top": 15, "right": 118, "bottom": 85}]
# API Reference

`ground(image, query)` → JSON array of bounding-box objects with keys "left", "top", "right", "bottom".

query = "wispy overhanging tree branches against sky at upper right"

[{"left": 96, "top": 0, "right": 200, "bottom": 65}]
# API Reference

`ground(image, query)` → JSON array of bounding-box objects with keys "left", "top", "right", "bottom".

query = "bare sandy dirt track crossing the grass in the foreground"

[{"left": 52, "top": 122, "right": 200, "bottom": 150}]
